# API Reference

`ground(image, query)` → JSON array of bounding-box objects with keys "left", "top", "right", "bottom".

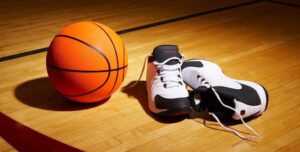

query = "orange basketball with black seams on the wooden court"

[{"left": 46, "top": 22, "right": 127, "bottom": 103}]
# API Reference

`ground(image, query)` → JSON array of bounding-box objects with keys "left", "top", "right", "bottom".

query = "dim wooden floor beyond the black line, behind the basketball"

[{"left": 0, "top": 0, "right": 250, "bottom": 57}]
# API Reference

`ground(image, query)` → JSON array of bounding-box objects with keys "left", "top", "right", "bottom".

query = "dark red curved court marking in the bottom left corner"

[{"left": 0, "top": 112, "right": 81, "bottom": 152}]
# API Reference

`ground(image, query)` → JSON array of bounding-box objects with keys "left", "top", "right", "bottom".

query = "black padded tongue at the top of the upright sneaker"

[{"left": 152, "top": 45, "right": 181, "bottom": 65}]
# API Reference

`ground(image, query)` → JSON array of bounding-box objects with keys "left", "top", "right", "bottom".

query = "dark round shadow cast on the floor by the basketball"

[{"left": 15, "top": 77, "right": 109, "bottom": 111}]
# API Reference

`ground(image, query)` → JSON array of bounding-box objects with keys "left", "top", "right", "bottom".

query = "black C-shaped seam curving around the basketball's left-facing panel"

[{"left": 55, "top": 35, "right": 111, "bottom": 97}]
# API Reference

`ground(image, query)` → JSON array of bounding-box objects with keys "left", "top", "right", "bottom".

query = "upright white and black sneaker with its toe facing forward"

[{"left": 146, "top": 45, "right": 191, "bottom": 116}]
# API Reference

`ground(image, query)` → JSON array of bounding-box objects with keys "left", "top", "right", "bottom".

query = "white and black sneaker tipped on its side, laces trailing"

[{"left": 182, "top": 59, "right": 268, "bottom": 138}]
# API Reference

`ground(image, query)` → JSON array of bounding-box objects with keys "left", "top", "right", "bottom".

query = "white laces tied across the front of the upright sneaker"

[{"left": 153, "top": 57, "right": 183, "bottom": 88}]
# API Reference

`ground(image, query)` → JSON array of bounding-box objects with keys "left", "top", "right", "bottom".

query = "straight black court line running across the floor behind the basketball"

[{"left": 0, "top": 0, "right": 264, "bottom": 62}]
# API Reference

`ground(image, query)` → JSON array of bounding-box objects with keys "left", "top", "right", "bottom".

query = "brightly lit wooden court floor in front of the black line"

[{"left": 0, "top": 2, "right": 300, "bottom": 151}]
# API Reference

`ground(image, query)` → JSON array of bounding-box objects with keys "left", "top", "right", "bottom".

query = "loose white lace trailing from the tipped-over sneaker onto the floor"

[{"left": 198, "top": 75, "right": 259, "bottom": 139}]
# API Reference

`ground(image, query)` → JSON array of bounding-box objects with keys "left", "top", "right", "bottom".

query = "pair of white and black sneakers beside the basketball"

[{"left": 146, "top": 45, "right": 268, "bottom": 138}]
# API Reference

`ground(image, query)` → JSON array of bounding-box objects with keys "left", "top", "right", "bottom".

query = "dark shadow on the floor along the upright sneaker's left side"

[{"left": 122, "top": 81, "right": 188, "bottom": 123}]
